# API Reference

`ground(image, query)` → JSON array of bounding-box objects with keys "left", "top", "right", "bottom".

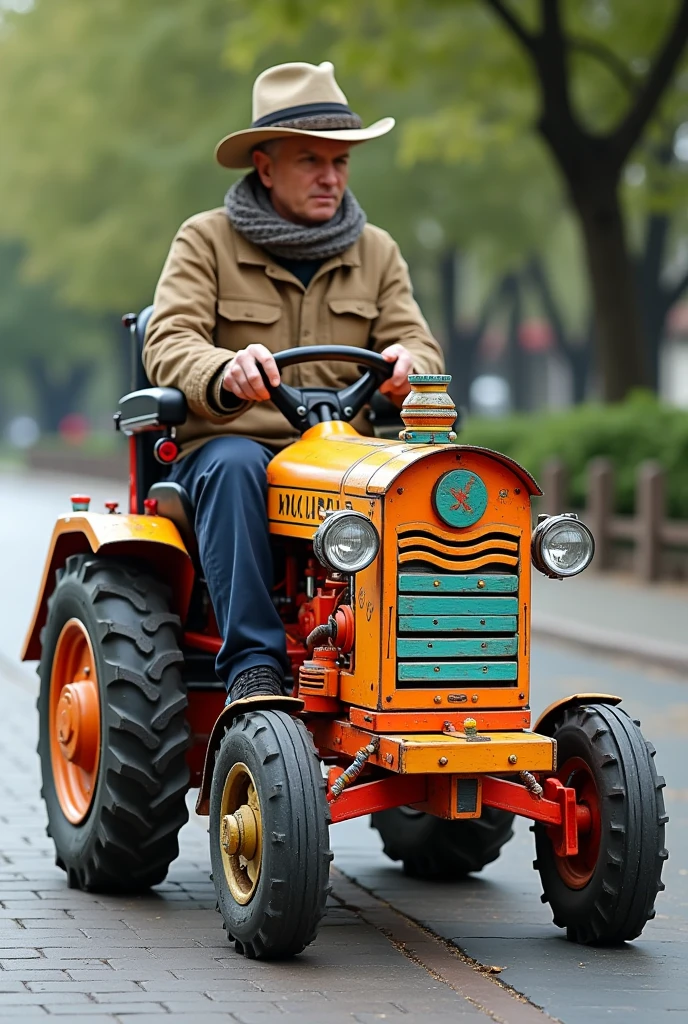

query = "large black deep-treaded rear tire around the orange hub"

[{"left": 38, "top": 555, "right": 189, "bottom": 892}]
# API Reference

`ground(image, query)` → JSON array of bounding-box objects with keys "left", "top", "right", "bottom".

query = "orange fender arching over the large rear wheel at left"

[{"left": 22, "top": 512, "right": 195, "bottom": 662}]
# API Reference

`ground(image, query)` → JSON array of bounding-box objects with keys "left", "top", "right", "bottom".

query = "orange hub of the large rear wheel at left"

[{"left": 49, "top": 618, "right": 100, "bottom": 825}]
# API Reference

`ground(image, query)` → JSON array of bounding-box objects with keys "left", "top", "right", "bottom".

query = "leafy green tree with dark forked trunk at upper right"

[{"left": 228, "top": 0, "right": 688, "bottom": 399}]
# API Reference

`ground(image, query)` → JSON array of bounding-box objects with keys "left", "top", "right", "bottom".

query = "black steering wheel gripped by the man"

[{"left": 258, "top": 345, "right": 394, "bottom": 431}]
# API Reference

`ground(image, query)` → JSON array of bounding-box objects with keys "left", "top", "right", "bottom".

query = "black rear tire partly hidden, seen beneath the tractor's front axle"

[{"left": 371, "top": 807, "right": 514, "bottom": 882}]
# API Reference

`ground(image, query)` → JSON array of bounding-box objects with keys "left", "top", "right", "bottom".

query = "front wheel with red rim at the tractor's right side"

[{"left": 533, "top": 705, "right": 669, "bottom": 945}]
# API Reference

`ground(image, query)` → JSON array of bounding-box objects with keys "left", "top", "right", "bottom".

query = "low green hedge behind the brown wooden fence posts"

[{"left": 459, "top": 391, "right": 688, "bottom": 519}]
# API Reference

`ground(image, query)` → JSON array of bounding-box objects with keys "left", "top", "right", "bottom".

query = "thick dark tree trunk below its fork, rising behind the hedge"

[{"left": 572, "top": 177, "right": 648, "bottom": 401}]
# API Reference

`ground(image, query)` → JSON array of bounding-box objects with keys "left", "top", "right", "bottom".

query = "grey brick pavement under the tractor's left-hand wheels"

[{"left": 0, "top": 675, "right": 540, "bottom": 1024}]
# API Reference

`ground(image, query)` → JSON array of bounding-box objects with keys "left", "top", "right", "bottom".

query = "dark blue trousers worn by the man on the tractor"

[{"left": 168, "top": 437, "right": 290, "bottom": 689}]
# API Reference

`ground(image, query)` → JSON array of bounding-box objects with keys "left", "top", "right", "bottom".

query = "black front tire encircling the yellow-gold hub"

[{"left": 209, "top": 711, "right": 333, "bottom": 959}]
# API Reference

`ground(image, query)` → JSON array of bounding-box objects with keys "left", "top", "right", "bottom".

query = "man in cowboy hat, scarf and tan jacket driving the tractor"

[{"left": 143, "top": 62, "right": 442, "bottom": 700}]
